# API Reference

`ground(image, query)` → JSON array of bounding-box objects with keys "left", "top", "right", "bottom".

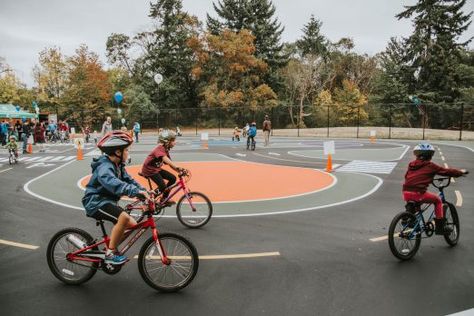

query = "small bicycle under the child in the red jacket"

[{"left": 388, "top": 177, "right": 466, "bottom": 260}]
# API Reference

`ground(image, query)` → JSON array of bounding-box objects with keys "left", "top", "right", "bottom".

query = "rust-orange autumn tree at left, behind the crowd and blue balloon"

[{"left": 61, "top": 45, "right": 112, "bottom": 125}]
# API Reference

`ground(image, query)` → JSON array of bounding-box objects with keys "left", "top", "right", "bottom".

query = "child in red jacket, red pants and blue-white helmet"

[{"left": 403, "top": 143, "right": 468, "bottom": 235}]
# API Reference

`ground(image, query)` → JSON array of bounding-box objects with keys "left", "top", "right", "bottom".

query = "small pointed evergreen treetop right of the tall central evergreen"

[{"left": 296, "top": 15, "right": 328, "bottom": 58}]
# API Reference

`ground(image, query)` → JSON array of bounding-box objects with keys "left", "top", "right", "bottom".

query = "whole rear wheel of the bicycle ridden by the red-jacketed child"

[{"left": 388, "top": 212, "right": 421, "bottom": 260}]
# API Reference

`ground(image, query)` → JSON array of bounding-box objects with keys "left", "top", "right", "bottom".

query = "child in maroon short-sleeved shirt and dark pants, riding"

[{"left": 141, "top": 130, "right": 186, "bottom": 206}]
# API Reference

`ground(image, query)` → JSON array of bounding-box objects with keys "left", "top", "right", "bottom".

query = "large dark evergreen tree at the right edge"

[{"left": 396, "top": 0, "right": 472, "bottom": 102}]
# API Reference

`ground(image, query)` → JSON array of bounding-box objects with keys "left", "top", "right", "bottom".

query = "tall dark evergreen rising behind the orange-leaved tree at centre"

[{"left": 207, "top": 0, "right": 288, "bottom": 73}]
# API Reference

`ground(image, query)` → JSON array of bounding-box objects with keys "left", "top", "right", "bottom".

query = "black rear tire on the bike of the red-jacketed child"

[{"left": 388, "top": 212, "right": 421, "bottom": 260}]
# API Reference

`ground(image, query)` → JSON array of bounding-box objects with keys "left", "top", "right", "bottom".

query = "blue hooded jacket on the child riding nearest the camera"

[{"left": 82, "top": 155, "right": 145, "bottom": 216}]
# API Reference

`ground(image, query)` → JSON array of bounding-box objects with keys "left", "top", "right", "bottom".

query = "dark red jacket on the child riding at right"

[{"left": 403, "top": 159, "right": 463, "bottom": 193}]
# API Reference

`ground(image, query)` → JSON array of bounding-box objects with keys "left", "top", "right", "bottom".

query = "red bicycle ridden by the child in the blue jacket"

[{"left": 46, "top": 194, "right": 199, "bottom": 292}]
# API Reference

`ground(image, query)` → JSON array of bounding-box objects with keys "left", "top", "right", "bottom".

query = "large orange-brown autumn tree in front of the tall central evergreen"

[{"left": 188, "top": 30, "right": 276, "bottom": 109}]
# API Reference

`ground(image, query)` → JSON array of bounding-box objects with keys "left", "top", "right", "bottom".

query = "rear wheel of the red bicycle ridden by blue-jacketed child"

[{"left": 46, "top": 228, "right": 98, "bottom": 285}]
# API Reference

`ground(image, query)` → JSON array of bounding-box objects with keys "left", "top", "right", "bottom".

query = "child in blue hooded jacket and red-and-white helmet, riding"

[{"left": 82, "top": 131, "right": 148, "bottom": 264}]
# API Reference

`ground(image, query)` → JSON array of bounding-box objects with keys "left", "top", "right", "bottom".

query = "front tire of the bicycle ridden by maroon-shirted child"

[{"left": 176, "top": 192, "right": 213, "bottom": 228}]
